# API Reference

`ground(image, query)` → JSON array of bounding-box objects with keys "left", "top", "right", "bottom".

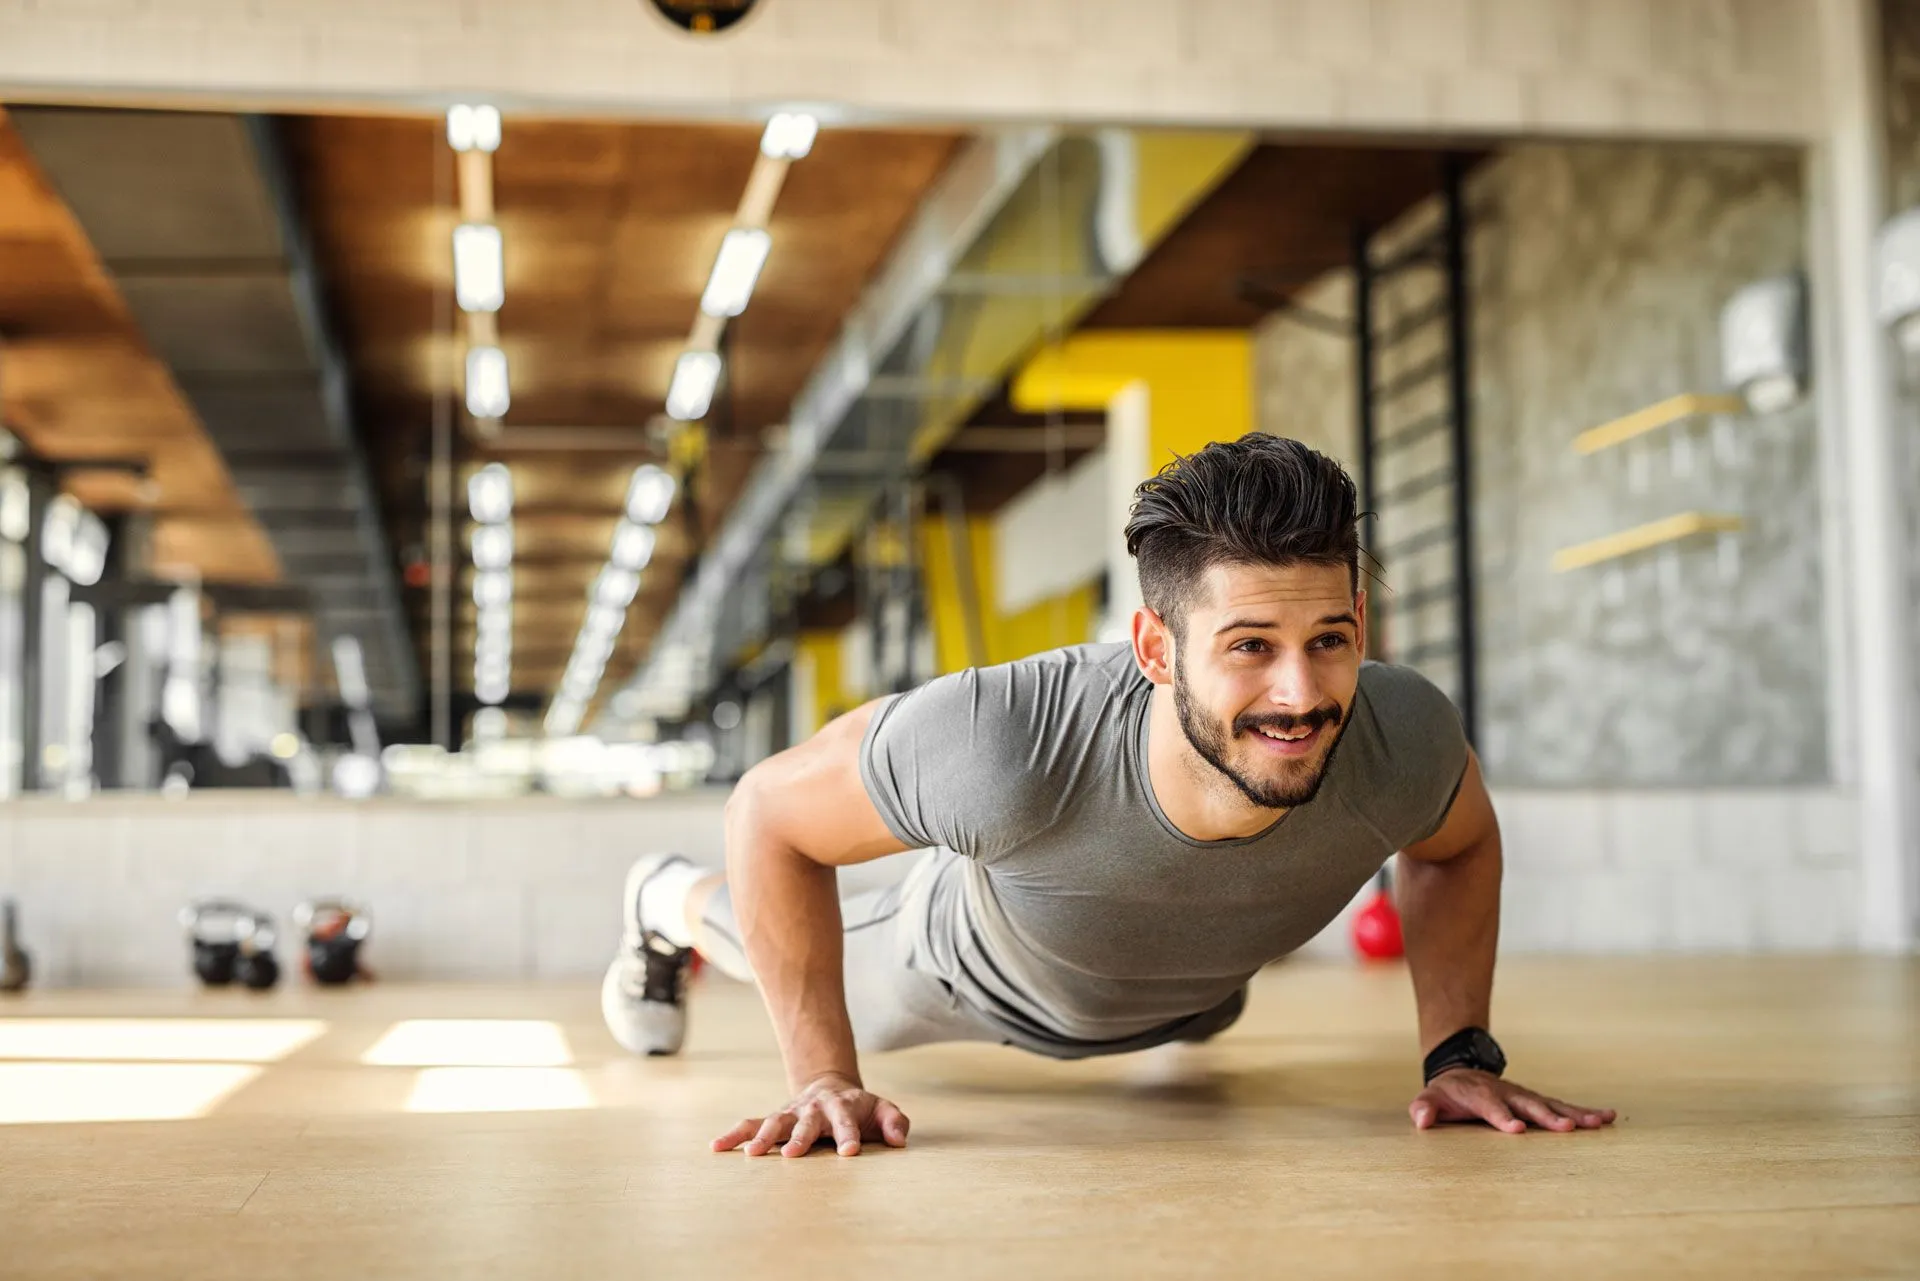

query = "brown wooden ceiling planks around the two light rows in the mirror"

[{"left": 286, "top": 117, "right": 958, "bottom": 691}]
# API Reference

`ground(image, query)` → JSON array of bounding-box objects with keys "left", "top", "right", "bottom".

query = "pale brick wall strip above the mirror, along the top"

[{"left": 0, "top": 0, "right": 1820, "bottom": 138}]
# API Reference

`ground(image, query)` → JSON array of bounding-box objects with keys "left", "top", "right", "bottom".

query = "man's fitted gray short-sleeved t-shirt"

[{"left": 860, "top": 643, "right": 1467, "bottom": 1045}]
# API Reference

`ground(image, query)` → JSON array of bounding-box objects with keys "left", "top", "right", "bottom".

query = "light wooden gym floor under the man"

[{"left": 0, "top": 958, "right": 1920, "bottom": 1281}]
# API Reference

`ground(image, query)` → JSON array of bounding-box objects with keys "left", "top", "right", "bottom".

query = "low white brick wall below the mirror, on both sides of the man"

[{"left": 0, "top": 789, "right": 1859, "bottom": 985}]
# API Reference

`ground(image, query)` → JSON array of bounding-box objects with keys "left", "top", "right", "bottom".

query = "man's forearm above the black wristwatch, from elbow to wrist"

[{"left": 1396, "top": 832, "right": 1501, "bottom": 1054}]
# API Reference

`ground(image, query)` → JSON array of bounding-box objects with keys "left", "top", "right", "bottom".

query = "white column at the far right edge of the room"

[{"left": 1812, "top": 0, "right": 1920, "bottom": 951}]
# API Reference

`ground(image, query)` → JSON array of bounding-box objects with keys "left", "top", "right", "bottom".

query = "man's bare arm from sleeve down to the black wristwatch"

[{"left": 1396, "top": 751, "right": 1501, "bottom": 1054}]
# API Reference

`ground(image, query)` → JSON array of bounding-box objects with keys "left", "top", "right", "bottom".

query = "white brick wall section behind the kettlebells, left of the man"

[{"left": 0, "top": 793, "right": 724, "bottom": 985}]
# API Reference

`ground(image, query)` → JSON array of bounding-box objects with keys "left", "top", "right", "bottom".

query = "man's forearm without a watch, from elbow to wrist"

[{"left": 726, "top": 801, "right": 860, "bottom": 1091}]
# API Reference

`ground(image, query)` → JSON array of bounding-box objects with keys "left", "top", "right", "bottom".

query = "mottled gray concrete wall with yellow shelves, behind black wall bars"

[{"left": 1256, "top": 146, "right": 1828, "bottom": 787}]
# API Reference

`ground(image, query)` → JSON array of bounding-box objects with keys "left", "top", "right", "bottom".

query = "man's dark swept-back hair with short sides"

[{"left": 1127, "top": 432, "right": 1359, "bottom": 634}]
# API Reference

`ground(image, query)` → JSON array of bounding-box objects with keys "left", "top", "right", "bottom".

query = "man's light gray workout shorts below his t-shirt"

[{"left": 701, "top": 862, "right": 1246, "bottom": 1058}]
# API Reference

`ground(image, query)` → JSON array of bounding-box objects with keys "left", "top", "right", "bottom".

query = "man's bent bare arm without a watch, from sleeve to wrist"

[{"left": 726, "top": 703, "right": 906, "bottom": 1091}]
